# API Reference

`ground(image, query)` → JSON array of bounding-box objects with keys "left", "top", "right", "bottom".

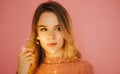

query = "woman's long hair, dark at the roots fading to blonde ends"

[{"left": 28, "top": 1, "right": 81, "bottom": 74}]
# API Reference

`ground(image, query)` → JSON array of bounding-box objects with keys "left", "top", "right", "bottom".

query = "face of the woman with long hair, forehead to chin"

[{"left": 37, "top": 12, "right": 64, "bottom": 53}]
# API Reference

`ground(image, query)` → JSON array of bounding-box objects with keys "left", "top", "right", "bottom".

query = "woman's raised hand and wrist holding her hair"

[{"left": 18, "top": 48, "right": 35, "bottom": 74}]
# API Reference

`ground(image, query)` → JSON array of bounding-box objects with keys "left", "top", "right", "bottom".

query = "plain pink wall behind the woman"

[{"left": 0, "top": 0, "right": 120, "bottom": 74}]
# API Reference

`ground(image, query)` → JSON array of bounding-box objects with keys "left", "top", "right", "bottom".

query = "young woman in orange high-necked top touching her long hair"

[{"left": 18, "top": 1, "right": 93, "bottom": 74}]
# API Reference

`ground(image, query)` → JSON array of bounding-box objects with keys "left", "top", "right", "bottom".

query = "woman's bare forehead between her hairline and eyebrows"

[{"left": 38, "top": 12, "right": 59, "bottom": 26}]
